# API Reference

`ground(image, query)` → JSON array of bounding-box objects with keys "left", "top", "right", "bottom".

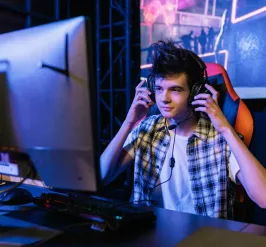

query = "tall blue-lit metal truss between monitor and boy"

[{"left": 96, "top": 0, "right": 139, "bottom": 151}]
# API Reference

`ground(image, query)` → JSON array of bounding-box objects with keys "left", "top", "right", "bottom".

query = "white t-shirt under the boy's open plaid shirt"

[{"left": 152, "top": 130, "right": 240, "bottom": 214}]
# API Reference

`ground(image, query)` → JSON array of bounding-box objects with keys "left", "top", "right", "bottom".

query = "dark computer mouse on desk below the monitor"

[{"left": 0, "top": 188, "right": 33, "bottom": 205}]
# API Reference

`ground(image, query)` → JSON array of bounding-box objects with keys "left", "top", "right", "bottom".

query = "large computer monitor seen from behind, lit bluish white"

[{"left": 0, "top": 17, "right": 100, "bottom": 192}]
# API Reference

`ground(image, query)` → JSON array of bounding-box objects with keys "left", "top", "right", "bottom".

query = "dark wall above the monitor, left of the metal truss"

[{"left": 0, "top": 0, "right": 95, "bottom": 30}]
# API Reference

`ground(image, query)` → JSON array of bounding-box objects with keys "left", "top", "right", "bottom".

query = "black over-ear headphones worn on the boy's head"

[{"left": 147, "top": 49, "right": 209, "bottom": 105}]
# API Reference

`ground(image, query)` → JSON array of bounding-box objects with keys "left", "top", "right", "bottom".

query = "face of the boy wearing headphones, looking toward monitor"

[{"left": 155, "top": 73, "right": 191, "bottom": 121}]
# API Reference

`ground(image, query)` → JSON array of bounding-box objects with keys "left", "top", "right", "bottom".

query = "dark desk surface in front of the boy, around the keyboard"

[{"left": 1, "top": 187, "right": 266, "bottom": 247}]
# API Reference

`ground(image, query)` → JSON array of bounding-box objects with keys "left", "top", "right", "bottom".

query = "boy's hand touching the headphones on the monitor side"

[{"left": 125, "top": 80, "right": 154, "bottom": 125}]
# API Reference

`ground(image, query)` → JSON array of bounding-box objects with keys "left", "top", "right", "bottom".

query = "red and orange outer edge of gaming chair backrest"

[{"left": 206, "top": 63, "right": 254, "bottom": 147}]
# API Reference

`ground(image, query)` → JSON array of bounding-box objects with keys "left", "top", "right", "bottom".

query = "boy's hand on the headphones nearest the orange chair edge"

[{"left": 192, "top": 84, "right": 231, "bottom": 133}]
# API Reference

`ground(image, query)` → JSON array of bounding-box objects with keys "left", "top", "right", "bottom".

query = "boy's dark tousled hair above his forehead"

[{"left": 149, "top": 40, "right": 204, "bottom": 89}]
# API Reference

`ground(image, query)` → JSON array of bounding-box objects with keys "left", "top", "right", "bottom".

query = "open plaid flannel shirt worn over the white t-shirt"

[{"left": 129, "top": 115, "right": 235, "bottom": 218}]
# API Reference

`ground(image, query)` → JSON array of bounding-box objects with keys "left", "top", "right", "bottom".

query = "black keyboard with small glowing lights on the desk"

[{"left": 34, "top": 193, "right": 156, "bottom": 230}]
